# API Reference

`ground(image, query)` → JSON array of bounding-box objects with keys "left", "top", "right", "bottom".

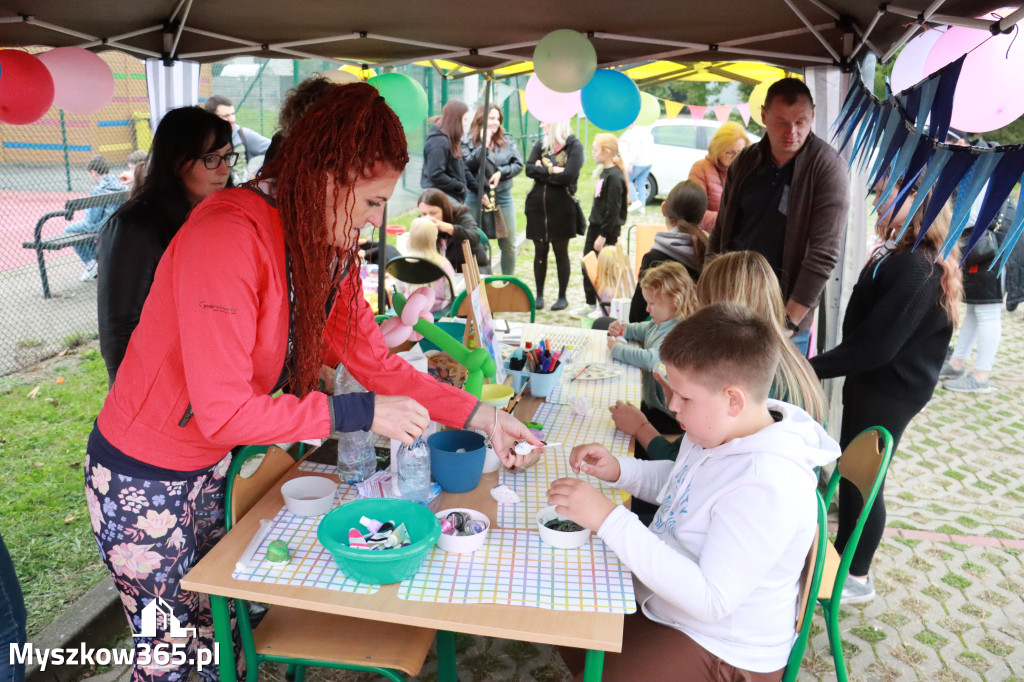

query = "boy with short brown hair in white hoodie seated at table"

[{"left": 548, "top": 303, "right": 840, "bottom": 682}]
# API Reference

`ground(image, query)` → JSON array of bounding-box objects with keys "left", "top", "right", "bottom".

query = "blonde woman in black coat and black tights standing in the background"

[{"left": 525, "top": 123, "right": 584, "bottom": 310}]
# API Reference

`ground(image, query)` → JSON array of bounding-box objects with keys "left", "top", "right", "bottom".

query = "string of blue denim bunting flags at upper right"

[{"left": 831, "top": 55, "right": 1024, "bottom": 271}]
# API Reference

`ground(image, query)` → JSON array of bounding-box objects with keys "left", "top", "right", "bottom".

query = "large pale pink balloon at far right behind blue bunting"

[{"left": 925, "top": 27, "right": 1024, "bottom": 132}]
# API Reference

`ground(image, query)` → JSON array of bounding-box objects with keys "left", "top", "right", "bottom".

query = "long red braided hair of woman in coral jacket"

[{"left": 258, "top": 83, "right": 409, "bottom": 395}]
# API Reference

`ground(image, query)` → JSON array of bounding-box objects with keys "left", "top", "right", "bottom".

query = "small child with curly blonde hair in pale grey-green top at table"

[{"left": 608, "top": 261, "right": 696, "bottom": 433}]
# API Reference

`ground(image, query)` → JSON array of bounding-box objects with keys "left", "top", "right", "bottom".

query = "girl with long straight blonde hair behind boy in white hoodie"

[{"left": 611, "top": 246, "right": 827, "bottom": 459}]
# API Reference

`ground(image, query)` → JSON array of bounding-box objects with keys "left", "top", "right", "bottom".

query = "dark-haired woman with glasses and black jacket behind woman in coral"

[{"left": 96, "top": 106, "right": 239, "bottom": 384}]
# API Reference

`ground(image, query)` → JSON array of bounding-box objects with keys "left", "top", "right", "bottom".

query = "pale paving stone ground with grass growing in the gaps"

[{"left": 86, "top": 214, "right": 1024, "bottom": 682}]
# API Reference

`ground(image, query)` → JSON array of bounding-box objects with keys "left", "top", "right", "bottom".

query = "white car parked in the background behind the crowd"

[{"left": 647, "top": 119, "right": 761, "bottom": 202}]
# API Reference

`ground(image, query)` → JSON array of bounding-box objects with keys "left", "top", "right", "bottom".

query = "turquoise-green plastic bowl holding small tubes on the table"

[{"left": 316, "top": 498, "right": 441, "bottom": 585}]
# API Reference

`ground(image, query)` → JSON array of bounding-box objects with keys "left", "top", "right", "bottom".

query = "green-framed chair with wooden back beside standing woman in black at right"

[{"left": 818, "top": 426, "right": 893, "bottom": 682}]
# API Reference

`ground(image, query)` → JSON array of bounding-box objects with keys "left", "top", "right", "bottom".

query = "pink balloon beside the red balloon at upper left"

[{"left": 37, "top": 47, "right": 114, "bottom": 114}]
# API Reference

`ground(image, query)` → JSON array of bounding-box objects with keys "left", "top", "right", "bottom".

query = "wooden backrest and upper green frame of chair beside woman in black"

[{"left": 824, "top": 426, "right": 893, "bottom": 599}]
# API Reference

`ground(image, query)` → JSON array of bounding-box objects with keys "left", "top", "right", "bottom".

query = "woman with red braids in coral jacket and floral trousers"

[{"left": 85, "top": 84, "right": 540, "bottom": 681}]
